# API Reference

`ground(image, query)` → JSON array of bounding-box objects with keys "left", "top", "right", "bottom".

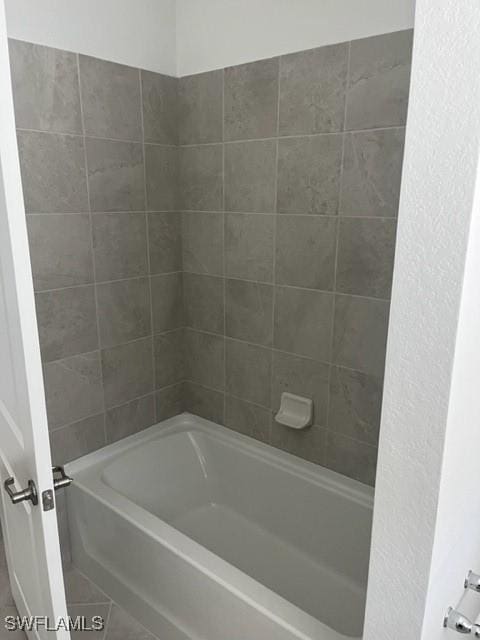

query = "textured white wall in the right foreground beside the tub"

[{"left": 364, "top": 0, "right": 480, "bottom": 640}]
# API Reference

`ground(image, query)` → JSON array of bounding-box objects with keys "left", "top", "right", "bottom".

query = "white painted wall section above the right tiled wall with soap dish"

[{"left": 177, "top": 0, "right": 415, "bottom": 76}]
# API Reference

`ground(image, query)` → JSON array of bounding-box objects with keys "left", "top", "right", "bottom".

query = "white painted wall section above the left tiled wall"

[{"left": 5, "top": 0, "right": 176, "bottom": 75}]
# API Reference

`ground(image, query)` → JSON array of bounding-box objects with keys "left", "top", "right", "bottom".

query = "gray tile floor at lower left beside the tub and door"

[{"left": 0, "top": 544, "right": 158, "bottom": 640}]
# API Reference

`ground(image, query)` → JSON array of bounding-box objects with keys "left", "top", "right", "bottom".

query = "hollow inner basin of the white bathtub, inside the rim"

[{"left": 95, "top": 425, "right": 372, "bottom": 637}]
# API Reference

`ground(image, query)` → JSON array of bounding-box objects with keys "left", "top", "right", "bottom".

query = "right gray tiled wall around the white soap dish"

[{"left": 178, "top": 31, "right": 412, "bottom": 484}]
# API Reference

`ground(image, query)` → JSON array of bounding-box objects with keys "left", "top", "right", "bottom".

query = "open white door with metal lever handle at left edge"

[{"left": 0, "top": 0, "right": 69, "bottom": 640}]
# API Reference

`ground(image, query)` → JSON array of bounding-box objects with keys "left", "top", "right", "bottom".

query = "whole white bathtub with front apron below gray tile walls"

[{"left": 67, "top": 414, "right": 373, "bottom": 640}]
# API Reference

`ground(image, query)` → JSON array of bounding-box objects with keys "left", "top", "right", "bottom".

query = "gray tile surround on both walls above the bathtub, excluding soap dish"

[{"left": 11, "top": 31, "right": 412, "bottom": 483}]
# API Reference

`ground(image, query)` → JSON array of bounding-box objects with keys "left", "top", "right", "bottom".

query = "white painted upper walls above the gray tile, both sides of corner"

[{"left": 5, "top": 0, "right": 415, "bottom": 76}]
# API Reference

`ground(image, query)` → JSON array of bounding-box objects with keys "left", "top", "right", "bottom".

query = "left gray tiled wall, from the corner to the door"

[{"left": 10, "top": 40, "right": 183, "bottom": 464}]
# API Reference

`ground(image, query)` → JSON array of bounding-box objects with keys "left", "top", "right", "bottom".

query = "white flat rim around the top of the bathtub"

[{"left": 66, "top": 413, "right": 373, "bottom": 640}]
